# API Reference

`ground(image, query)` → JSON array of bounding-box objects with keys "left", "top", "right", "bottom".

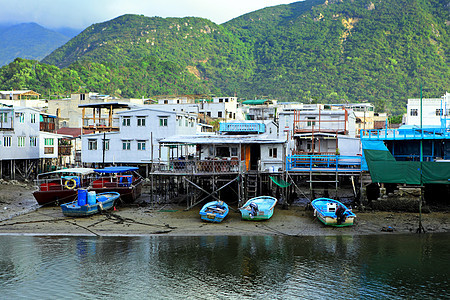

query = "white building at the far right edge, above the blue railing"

[{"left": 406, "top": 92, "right": 450, "bottom": 127}]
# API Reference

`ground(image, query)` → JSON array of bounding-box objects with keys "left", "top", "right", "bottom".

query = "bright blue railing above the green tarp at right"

[{"left": 360, "top": 127, "right": 450, "bottom": 141}]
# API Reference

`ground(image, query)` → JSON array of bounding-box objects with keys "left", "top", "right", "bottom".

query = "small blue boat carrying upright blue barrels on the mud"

[{"left": 61, "top": 192, "right": 120, "bottom": 217}]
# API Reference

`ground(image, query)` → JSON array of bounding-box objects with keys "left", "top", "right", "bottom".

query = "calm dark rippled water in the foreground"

[{"left": 0, "top": 234, "right": 450, "bottom": 299}]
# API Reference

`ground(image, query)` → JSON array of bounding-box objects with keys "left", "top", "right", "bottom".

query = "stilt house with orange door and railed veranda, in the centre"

[{"left": 160, "top": 121, "right": 286, "bottom": 173}]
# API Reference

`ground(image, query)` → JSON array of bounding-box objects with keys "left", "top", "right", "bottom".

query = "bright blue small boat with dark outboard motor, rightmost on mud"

[{"left": 311, "top": 198, "right": 356, "bottom": 227}]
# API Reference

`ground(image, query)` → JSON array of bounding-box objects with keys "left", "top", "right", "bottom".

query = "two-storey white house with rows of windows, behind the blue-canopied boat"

[{"left": 81, "top": 106, "right": 197, "bottom": 165}]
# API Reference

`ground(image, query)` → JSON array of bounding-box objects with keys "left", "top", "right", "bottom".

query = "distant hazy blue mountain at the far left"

[{"left": 0, "top": 23, "right": 69, "bottom": 66}]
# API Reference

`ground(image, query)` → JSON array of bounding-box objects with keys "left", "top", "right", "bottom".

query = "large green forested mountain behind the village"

[{"left": 5, "top": 0, "right": 450, "bottom": 114}]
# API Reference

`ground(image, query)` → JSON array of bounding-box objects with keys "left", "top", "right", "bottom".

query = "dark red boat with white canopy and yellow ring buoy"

[{"left": 33, "top": 168, "right": 94, "bottom": 205}]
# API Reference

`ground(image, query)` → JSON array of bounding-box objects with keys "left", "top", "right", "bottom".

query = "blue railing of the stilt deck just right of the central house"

[{"left": 286, "top": 155, "right": 363, "bottom": 172}]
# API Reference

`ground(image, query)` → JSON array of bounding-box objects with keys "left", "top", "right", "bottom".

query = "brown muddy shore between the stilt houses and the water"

[{"left": 0, "top": 182, "right": 450, "bottom": 236}]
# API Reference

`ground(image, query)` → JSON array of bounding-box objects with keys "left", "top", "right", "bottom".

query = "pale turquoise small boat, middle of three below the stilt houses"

[{"left": 239, "top": 196, "right": 277, "bottom": 220}]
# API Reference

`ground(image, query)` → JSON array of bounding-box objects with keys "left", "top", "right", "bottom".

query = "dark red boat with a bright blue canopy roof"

[{"left": 89, "top": 166, "right": 144, "bottom": 202}]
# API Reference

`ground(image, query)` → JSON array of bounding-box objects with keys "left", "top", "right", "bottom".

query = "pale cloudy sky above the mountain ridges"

[{"left": 0, "top": 0, "right": 298, "bottom": 29}]
